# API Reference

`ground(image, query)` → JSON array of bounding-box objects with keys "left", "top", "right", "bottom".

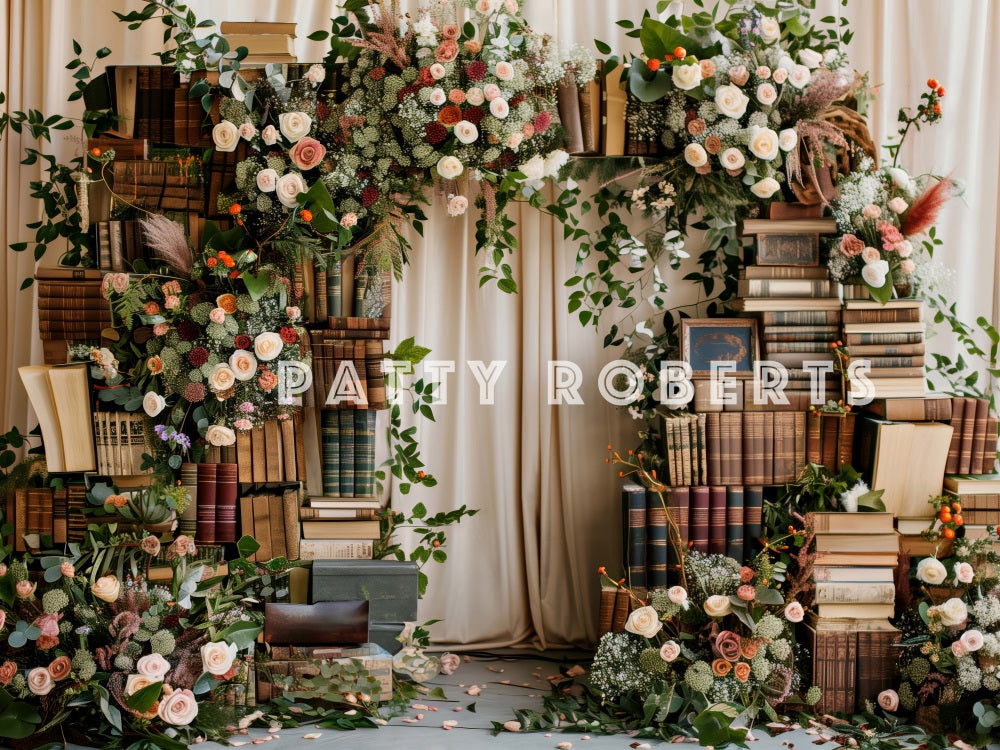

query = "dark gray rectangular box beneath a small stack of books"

[{"left": 309, "top": 560, "right": 419, "bottom": 624}]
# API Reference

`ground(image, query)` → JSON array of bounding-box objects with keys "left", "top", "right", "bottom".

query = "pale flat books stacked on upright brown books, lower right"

[{"left": 802, "top": 513, "right": 900, "bottom": 713}]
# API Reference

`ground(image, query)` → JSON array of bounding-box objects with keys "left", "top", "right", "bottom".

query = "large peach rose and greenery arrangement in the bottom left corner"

[{"left": 0, "top": 527, "right": 260, "bottom": 749}]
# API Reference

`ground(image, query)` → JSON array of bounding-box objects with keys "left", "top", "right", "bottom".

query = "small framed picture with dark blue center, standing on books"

[{"left": 681, "top": 318, "right": 760, "bottom": 379}]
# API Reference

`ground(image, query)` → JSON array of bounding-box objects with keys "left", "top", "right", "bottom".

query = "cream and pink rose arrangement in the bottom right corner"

[{"left": 896, "top": 533, "right": 1000, "bottom": 744}]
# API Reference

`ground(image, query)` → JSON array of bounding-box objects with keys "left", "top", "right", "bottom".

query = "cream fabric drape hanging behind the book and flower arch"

[{"left": 0, "top": 0, "right": 1000, "bottom": 646}]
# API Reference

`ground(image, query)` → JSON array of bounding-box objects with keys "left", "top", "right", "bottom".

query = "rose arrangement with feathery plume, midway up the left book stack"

[{"left": 100, "top": 216, "right": 311, "bottom": 469}]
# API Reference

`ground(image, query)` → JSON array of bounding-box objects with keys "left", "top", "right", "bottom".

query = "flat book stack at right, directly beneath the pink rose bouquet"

[{"left": 843, "top": 299, "right": 924, "bottom": 398}]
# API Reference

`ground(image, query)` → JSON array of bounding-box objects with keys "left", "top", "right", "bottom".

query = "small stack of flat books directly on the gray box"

[{"left": 299, "top": 496, "right": 382, "bottom": 560}]
